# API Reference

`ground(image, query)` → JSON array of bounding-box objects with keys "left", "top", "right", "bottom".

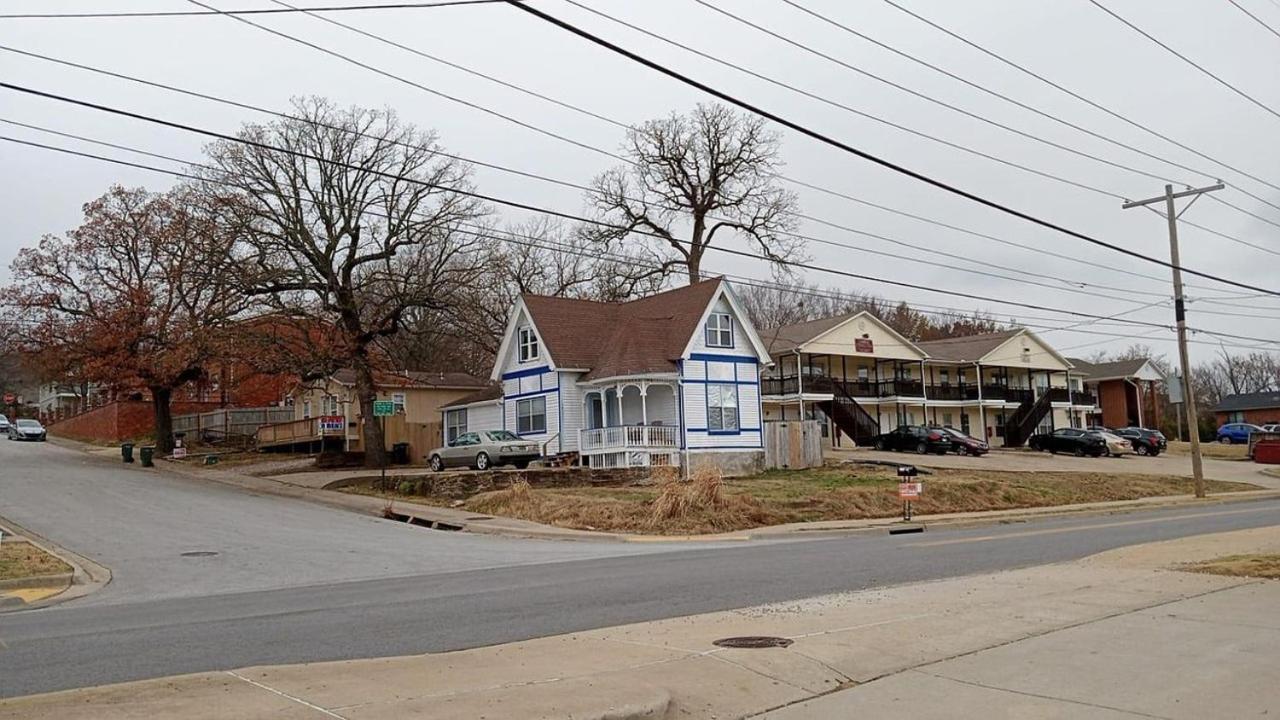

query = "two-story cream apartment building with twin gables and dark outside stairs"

[{"left": 762, "top": 311, "right": 1096, "bottom": 446}]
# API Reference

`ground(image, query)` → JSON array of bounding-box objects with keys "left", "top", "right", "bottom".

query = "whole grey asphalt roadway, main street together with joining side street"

[{"left": 0, "top": 435, "right": 1280, "bottom": 697}]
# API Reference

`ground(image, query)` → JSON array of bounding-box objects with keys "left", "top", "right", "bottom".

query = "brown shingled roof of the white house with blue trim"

[{"left": 524, "top": 278, "right": 723, "bottom": 380}]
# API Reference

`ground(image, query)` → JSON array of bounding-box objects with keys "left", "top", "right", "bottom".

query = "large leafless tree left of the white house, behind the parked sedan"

[{"left": 202, "top": 99, "right": 486, "bottom": 465}]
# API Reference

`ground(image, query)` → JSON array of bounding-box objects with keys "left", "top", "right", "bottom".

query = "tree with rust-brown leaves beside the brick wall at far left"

[{"left": 8, "top": 187, "right": 244, "bottom": 452}]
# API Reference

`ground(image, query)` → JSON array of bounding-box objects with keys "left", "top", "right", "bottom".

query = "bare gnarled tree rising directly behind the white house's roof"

[{"left": 588, "top": 104, "right": 804, "bottom": 283}]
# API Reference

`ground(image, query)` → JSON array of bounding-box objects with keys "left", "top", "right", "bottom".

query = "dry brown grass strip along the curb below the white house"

[{"left": 351, "top": 464, "right": 1257, "bottom": 534}]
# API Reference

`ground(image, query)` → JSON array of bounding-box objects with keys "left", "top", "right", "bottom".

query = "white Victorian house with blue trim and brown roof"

[{"left": 443, "top": 279, "right": 769, "bottom": 474}]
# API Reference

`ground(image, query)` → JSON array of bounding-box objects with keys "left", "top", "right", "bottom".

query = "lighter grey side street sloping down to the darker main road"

[{"left": 0, "top": 442, "right": 721, "bottom": 606}]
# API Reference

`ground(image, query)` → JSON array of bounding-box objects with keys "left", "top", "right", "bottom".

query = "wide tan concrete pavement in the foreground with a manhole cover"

[{"left": 0, "top": 527, "right": 1280, "bottom": 720}]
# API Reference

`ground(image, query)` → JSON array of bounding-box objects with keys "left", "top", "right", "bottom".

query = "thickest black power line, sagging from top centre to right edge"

[{"left": 504, "top": 0, "right": 1280, "bottom": 296}]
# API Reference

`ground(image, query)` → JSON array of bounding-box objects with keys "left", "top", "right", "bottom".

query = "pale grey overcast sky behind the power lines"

[{"left": 0, "top": 0, "right": 1280, "bottom": 360}]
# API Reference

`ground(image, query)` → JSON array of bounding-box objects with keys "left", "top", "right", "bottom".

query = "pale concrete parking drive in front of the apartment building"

[{"left": 828, "top": 450, "right": 1280, "bottom": 489}]
